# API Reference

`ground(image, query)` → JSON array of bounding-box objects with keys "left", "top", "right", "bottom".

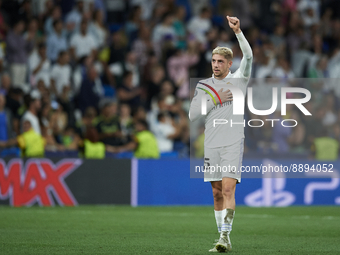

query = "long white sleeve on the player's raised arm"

[{"left": 236, "top": 32, "right": 253, "bottom": 78}]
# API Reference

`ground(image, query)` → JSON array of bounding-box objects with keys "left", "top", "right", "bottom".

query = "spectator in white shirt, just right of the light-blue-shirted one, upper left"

[{"left": 70, "top": 19, "right": 97, "bottom": 61}]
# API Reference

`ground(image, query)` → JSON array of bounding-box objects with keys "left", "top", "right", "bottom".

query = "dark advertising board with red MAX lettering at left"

[{"left": 0, "top": 158, "right": 131, "bottom": 206}]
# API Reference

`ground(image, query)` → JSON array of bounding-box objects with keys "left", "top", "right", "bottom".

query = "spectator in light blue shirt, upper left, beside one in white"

[{"left": 47, "top": 19, "right": 68, "bottom": 63}]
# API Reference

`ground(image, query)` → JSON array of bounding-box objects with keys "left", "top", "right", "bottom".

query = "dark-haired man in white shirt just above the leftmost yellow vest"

[{"left": 21, "top": 90, "right": 41, "bottom": 135}]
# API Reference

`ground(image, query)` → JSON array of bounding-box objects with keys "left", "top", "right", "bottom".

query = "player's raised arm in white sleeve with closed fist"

[{"left": 227, "top": 16, "right": 253, "bottom": 78}]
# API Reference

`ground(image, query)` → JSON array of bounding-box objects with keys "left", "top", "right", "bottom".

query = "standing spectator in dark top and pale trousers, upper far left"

[{"left": 6, "top": 20, "right": 34, "bottom": 86}]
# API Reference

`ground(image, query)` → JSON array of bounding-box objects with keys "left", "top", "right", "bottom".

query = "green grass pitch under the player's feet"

[{"left": 0, "top": 206, "right": 340, "bottom": 255}]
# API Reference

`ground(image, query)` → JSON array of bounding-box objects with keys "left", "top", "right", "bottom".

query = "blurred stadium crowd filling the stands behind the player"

[{"left": 0, "top": 0, "right": 340, "bottom": 158}]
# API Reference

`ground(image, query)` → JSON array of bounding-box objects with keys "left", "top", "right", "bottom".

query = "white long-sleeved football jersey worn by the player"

[{"left": 189, "top": 33, "right": 252, "bottom": 148}]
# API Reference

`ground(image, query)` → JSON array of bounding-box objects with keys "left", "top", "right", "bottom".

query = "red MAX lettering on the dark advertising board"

[{"left": 0, "top": 159, "right": 82, "bottom": 206}]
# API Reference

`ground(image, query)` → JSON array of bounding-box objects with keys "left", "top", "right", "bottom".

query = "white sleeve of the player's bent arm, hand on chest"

[{"left": 189, "top": 86, "right": 215, "bottom": 121}]
